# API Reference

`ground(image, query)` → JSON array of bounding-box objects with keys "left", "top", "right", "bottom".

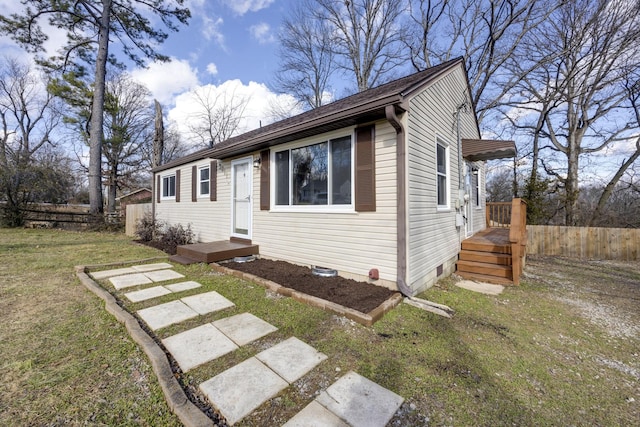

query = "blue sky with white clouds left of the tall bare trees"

[{"left": 0, "top": 0, "right": 296, "bottom": 144}]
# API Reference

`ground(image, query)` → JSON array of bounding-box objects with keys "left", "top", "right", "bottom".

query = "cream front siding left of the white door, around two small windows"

[{"left": 156, "top": 159, "right": 231, "bottom": 242}]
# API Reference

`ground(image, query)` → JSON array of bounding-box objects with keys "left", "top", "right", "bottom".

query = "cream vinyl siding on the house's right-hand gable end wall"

[{"left": 407, "top": 68, "right": 479, "bottom": 292}]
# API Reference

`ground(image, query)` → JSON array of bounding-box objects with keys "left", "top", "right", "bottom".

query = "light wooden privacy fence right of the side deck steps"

[{"left": 527, "top": 225, "right": 640, "bottom": 261}]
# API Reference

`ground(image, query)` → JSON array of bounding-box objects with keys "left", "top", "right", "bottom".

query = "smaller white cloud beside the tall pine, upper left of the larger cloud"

[{"left": 131, "top": 59, "right": 198, "bottom": 104}]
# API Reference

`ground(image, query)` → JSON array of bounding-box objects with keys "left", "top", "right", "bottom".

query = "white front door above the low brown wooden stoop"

[{"left": 231, "top": 157, "right": 253, "bottom": 239}]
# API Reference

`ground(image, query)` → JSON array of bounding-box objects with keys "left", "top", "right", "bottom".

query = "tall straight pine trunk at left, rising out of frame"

[{"left": 89, "top": 0, "right": 111, "bottom": 216}]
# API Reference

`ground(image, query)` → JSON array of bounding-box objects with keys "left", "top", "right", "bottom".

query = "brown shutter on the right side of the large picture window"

[{"left": 355, "top": 125, "right": 376, "bottom": 212}]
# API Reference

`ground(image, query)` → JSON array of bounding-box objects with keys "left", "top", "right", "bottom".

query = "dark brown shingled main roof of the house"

[{"left": 154, "top": 58, "right": 462, "bottom": 172}]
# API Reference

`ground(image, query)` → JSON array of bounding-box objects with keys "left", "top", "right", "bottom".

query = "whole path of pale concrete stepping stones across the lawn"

[{"left": 91, "top": 263, "right": 404, "bottom": 427}]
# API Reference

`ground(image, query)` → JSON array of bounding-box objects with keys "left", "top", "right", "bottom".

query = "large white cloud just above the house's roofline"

[{"left": 168, "top": 79, "right": 301, "bottom": 148}]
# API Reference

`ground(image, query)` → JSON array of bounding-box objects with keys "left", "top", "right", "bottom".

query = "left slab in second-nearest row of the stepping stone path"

[{"left": 200, "top": 357, "right": 289, "bottom": 425}]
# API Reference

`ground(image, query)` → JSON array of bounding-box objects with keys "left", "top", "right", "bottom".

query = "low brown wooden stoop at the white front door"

[{"left": 169, "top": 240, "right": 259, "bottom": 265}]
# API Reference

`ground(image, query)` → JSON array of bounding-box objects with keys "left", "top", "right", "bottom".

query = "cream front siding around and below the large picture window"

[{"left": 252, "top": 121, "right": 397, "bottom": 286}]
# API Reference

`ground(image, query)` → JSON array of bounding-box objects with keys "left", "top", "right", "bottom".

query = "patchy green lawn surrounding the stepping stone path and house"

[{"left": 0, "top": 229, "right": 640, "bottom": 426}]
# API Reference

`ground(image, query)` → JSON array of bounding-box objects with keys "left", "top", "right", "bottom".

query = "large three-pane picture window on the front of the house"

[{"left": 275, "top": 136, "right": 353, "bottom": 206}]
